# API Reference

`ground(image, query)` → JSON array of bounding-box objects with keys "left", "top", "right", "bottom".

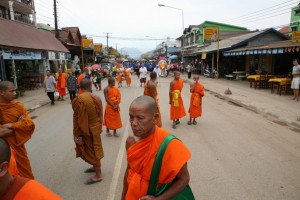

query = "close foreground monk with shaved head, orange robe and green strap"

[{"left": 121, "top": 96, "right": 191, "bottom": 200}]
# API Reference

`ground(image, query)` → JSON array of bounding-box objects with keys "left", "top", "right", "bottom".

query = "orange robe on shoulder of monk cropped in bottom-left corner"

[{"left": 0, "top": 176, "right": 62, "bottom": 200}]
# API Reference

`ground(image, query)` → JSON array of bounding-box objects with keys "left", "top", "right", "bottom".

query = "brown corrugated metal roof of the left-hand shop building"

[{"left": 0, "top": 18, "right": 69, "bottom": 52}]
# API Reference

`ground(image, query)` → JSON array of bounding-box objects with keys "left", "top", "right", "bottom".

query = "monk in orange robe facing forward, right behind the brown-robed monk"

[{"left": 103, "top": 77, "right": 122, "bottom": 137}]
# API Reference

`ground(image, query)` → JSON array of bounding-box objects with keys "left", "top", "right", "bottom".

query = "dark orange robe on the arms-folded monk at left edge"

[{"left": 0, "top": 101, "right": 35, "bottom": 179}]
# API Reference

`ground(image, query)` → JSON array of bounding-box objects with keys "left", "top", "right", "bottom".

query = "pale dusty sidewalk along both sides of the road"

[{"left": 17, "top": 74, "right": 300, "bottom": 128}]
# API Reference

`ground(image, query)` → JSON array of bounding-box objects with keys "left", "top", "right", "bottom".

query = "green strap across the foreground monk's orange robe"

[{"left": 147, "top": 135, "right": 177, "bottom": 195}]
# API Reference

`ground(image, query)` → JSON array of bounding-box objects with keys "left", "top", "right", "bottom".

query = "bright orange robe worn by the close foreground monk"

[{"left": 125, "top": 127, "right": 191, "bottom": 200}]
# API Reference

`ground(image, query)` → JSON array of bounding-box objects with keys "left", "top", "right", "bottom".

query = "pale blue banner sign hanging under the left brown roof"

[{"left": 2, "top": 50, "right": 42, "bottom": 60}]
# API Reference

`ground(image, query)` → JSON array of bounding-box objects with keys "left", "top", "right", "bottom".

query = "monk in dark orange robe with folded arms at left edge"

[{"left": 0, "top": 81, "right": 35, "bottom": 179}]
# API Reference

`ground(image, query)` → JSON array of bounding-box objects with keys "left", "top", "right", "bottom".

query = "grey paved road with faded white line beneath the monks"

[{"left": 27, "top": 76, "right": 300, "bottom": 200}]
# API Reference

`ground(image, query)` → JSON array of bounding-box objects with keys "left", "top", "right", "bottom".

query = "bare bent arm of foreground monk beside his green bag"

[{"left": 140, "top": 164, "right": 190, "bottom": 200}]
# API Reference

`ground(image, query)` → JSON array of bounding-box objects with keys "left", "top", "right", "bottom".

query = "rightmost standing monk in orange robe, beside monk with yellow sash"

[{"left": 188, "top": 76, "right": 204, "bottom": 125}]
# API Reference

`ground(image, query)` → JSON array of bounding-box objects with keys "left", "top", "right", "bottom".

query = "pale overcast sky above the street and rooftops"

[{"left": 35, "top": 0, "right": 299, "bottom": 51}]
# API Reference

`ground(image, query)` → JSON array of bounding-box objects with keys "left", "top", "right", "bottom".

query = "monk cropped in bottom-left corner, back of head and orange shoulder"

[{"left": 0, "top": 138, "right": 62, "bottom": 200}]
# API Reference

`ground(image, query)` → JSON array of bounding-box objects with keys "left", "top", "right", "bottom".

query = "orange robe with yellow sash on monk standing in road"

[{"left": 170, "top": 79, "right": 186, "bottom": 120}]
